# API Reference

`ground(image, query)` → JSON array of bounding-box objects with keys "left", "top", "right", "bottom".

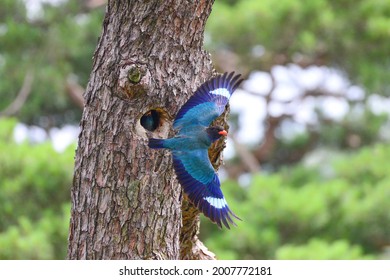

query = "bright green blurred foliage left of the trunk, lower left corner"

[{"left": 0, "top": 119, "right": 74, "bottom": 259}]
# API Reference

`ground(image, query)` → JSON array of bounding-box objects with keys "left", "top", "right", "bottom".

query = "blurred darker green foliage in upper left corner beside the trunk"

[{"left": 0, "top": 0, "right": 103, "bottom": 126}]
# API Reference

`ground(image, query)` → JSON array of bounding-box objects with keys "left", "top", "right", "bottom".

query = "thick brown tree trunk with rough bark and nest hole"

[{"left": 68, "top": 0, "right": 221, "bottom": 259}]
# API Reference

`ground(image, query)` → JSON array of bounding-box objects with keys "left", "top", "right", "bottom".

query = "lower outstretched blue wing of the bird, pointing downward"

[{"left": 173, "top": 149, "right": 240, "bottom": 228}]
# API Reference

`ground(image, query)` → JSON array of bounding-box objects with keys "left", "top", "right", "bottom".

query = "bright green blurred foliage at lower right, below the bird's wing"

[{"left": 201, "top": 144, "right": 390, "bottom": 259}]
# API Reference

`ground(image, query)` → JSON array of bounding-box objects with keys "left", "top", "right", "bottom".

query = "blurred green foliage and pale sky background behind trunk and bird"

[{"left": 0, "top": 0, "right": 390, "bottom": 259}]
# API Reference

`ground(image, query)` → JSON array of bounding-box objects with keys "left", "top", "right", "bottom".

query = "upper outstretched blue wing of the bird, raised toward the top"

[{"left": 173, "top": 72, "right": 243, "bottom": 129}]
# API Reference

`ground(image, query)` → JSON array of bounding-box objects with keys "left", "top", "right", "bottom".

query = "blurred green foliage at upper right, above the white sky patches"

[{"left": 206, "top": 0, "right": 390, "bottom": 94}]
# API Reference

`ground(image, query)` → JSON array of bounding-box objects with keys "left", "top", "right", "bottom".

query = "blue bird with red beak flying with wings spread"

[{"left": 149, "top": 72, "right": 242, "bottom": 228}]
